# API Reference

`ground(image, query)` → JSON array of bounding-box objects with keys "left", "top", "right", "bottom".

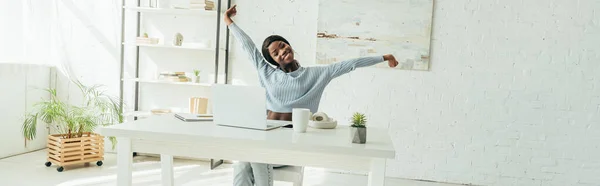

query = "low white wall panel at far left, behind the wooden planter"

[{"left": 0, "top": 63, "right": 51, "bottom": 158}]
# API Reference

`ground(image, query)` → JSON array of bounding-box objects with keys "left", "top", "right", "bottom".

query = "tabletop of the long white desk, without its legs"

[{"left": 100, "top": 114, "right": 395, "bottom": 158}]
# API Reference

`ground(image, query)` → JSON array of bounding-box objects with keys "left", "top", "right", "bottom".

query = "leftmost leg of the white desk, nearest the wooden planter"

[{"left": 117, "top": 137, "right": 133, "bottom": 186}]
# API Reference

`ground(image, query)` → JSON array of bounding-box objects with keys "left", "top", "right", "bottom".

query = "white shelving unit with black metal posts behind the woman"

[{"left": 119, "top": 0, "right": 230, "bottom": 129}]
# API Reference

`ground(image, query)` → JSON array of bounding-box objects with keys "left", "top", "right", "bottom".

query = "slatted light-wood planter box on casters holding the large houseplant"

[{"left": 46, "top": 132, "right": 104, "bottom": 172}]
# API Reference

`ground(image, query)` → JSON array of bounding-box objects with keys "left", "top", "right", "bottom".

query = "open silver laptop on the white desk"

[{"left": 212, "top": 84, "right": 292, "bottom": 130}]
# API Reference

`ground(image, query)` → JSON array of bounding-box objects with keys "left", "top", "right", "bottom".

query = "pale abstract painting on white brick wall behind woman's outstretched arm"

[{"left": 316, "top": 0, "right": 433, "bottom": 71}]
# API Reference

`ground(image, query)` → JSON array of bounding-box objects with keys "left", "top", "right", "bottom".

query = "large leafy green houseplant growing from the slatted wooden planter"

[{"left": 22, "top": 81, "right": 123, "bottom": 149}]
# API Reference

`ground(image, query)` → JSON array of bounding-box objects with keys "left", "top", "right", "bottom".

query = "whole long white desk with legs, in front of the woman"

[{"left": 100, "top": 115, "right": 395, "bottom": 186}]
